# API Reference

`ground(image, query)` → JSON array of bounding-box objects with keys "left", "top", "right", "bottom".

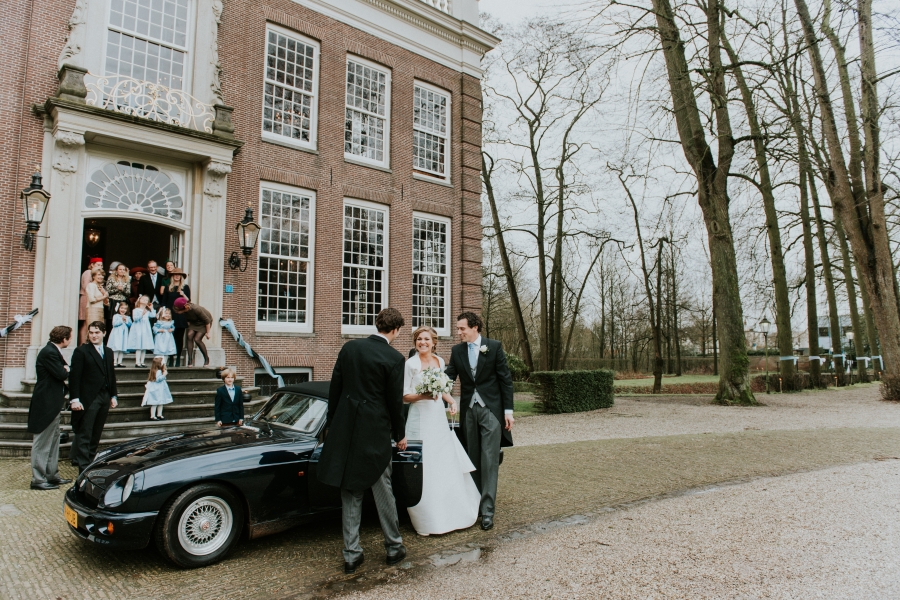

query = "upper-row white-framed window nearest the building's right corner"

[{"left": 413, "top": 83, "right": 450, "bottom": 178}]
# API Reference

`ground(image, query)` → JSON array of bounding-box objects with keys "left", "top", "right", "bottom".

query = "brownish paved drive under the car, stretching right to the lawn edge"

[{"left": 0, "top": 387, "right": 900, "bottom": 600}]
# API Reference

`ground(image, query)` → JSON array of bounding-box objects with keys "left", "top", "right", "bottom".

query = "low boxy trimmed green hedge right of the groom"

[{"left": 529, "top": 369, "right": 615, "bottom": 413}]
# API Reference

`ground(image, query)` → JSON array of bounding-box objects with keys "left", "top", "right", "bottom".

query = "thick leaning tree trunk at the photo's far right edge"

[{"left": 794, "top": 0, "right": 900, "bottom": 375}]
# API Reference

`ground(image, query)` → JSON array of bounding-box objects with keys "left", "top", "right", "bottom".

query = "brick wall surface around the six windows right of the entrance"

[{"left": 219, "top": 0, "right": 481, "bottom": 379}]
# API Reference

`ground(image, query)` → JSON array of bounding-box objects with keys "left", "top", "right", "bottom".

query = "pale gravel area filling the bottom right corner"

[{"left": 340, "top": 460, "right": 900, "bottom": 599}]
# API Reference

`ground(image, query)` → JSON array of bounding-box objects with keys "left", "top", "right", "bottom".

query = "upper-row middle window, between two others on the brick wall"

[{"left": 344, "top": 58, "right": 391, "bottom": 166}]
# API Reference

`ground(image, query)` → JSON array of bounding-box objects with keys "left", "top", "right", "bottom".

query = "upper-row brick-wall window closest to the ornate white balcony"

[{"left": 263, "top": 26, "right": 319, "bottom": 147}]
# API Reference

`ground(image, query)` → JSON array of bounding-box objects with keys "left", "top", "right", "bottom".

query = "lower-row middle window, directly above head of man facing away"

[{"left": 341, "top": 201, "right": 387, "bottom": 329}]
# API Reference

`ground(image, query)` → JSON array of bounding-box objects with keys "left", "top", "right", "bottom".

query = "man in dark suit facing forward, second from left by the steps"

[{"left": 69, "top": 321, "right": 118, "bottom": 473}]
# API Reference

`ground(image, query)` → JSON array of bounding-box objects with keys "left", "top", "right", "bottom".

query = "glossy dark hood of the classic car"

[{"left": 96, "top": 426, "right": 297, "bottom": 479}]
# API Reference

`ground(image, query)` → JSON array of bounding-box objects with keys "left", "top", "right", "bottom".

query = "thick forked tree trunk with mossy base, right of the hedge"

[{"left": 653, "top": 0, "right": 756, "bottom": 404}]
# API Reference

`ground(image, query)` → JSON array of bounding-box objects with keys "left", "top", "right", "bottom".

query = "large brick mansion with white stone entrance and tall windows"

[{"left": 0, "top": 0, "right": 498, "bottom": 391}]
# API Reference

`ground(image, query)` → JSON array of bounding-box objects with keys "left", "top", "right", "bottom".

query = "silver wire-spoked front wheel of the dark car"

[{"left": 156, "top": 484, "right": 244, "bottom": 569}]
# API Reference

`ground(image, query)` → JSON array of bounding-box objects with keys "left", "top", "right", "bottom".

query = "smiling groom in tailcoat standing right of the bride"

[{"left": 445, "top": 312, "right": 515, "bottom": 531}]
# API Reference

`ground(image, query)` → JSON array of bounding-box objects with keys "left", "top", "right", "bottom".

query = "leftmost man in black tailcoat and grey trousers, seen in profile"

[{"left": 28, "top": 325, "right": 72, "bottom": 490}]
